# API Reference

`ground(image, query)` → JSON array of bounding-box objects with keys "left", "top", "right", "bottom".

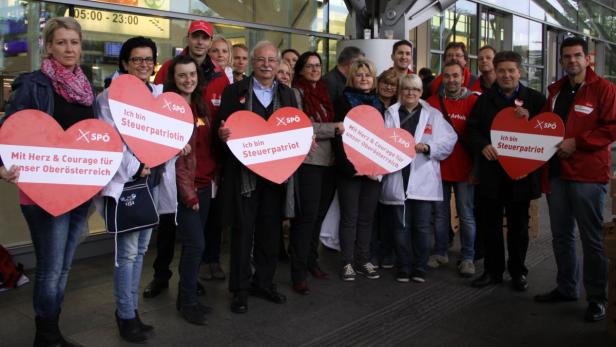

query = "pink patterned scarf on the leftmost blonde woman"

[{"left": 41, "top": 58, "right": 94, "bottom": 106}]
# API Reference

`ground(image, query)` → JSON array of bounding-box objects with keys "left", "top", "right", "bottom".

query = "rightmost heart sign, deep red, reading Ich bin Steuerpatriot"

[{"left": 490, "top": 107, "right": 565, "bottom": 179}]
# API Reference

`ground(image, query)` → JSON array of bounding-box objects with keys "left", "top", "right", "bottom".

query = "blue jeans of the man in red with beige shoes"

[{"left": 434, "top": 181, "right": 476, "bottom": 261}]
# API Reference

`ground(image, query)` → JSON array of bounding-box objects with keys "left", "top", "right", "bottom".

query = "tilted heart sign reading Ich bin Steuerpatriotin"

[{"left": 109, "top": 74, "right": 194, "bottom": 167}]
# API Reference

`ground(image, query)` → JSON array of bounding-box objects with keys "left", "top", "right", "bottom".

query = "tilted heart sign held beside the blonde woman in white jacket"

[{"left": 342, "top": 105, "right": 415, "bottom": 175}]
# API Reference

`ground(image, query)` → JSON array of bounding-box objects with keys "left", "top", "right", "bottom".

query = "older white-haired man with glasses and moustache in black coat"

[{"left": 218, "top": 41, "right": 297, "bottom": 313}]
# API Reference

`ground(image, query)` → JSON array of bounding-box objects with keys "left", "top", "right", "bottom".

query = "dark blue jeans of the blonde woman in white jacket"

[{"left": 385, "top": 200, "right": 433, "bottom": 275}]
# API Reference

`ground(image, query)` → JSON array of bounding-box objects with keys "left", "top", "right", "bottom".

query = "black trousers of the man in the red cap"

[{"left": 154, "top": 213, "right": 175, "bottom": 282}]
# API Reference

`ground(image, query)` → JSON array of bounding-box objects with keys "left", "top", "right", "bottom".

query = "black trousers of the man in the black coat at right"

[{"left": 481, "top": 199, "right": 530, "bottom": 278}]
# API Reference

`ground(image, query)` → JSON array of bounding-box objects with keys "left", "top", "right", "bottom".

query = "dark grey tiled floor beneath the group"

[{"left": 0, "top": 198, "right": 616, "bottom": 347}]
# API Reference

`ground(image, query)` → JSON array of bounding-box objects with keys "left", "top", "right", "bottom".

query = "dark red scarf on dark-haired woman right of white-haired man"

[{"left": 294, "top": 77, "right": 334, "bottom": 123}]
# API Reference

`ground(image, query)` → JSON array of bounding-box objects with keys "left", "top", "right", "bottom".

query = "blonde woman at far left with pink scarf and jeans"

[{"left": 0, "top": 17, "right": 94, "bottom": 346}]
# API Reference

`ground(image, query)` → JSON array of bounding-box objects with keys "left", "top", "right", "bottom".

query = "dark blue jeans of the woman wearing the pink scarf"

[{"left": 21, "top": 201, "right": 90, "bottom": 319}]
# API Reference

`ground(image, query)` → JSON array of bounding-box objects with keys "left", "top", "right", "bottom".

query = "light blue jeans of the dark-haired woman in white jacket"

[{"left": 113, "top": 228, "right": 152, "bottom": 319}]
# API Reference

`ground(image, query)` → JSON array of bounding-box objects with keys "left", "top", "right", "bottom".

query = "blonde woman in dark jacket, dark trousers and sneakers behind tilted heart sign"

[{"left": 333, "top": 59, "right": 383, "bottom": 281}]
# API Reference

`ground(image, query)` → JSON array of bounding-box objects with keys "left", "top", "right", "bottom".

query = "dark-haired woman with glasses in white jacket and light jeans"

[{"left": 96, "top": 36, "right": 180, "bottom": 342}]
